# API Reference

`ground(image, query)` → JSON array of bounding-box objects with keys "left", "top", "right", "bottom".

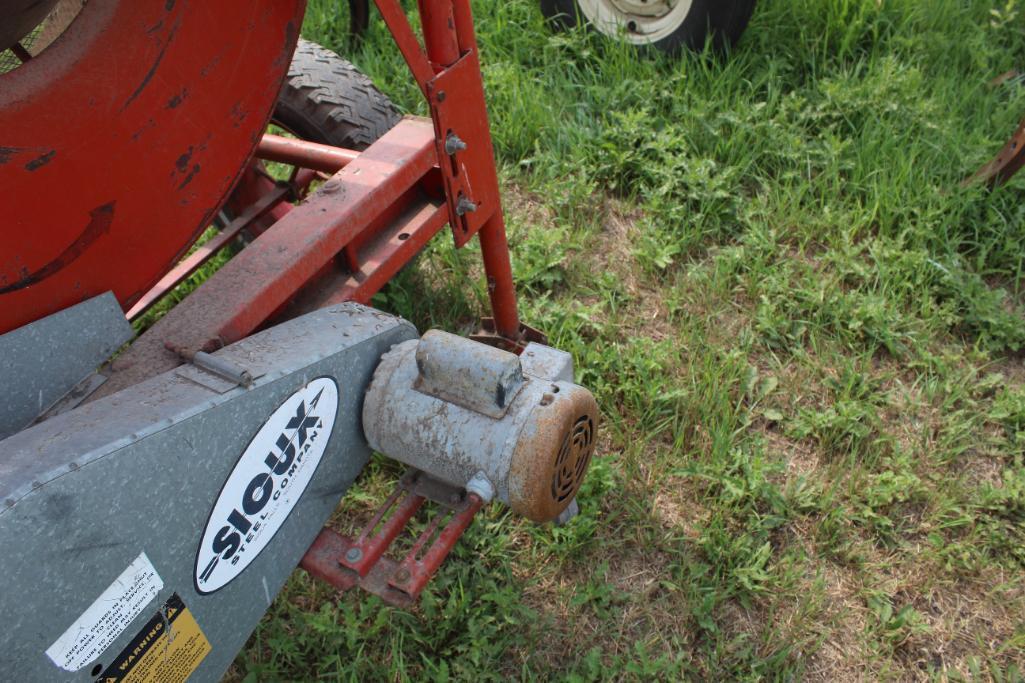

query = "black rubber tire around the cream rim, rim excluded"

[{"left": 540, "top": 0, "right": 756, "bottom": 54}]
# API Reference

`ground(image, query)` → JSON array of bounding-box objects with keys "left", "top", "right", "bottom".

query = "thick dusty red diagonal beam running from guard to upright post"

[{"left": 93, "top": 118, "right": 437, "bottom": 398}]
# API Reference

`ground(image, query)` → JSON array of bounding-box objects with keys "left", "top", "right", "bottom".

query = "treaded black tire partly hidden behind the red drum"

[{"left": 272, "top": 39, "right": 402, "bottom": 150}]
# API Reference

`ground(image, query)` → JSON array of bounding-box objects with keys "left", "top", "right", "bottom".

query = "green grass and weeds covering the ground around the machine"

[{"left": 231, "top": 0, "right": 1025, "bottom": 681}]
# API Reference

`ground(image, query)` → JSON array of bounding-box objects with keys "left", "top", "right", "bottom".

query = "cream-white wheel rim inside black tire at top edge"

[{"left": 577, "top": 0, "right": 694, "bottom": 45}]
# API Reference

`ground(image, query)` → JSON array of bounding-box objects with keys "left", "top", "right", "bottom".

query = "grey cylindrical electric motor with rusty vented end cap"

[{"left": 363, "top": 330, "right": 598, "bottom": 522}]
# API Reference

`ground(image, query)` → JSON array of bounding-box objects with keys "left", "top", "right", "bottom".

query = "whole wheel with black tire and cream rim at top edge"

[{"left": 540, "top": 0, "right": 756, "bottom": 54}]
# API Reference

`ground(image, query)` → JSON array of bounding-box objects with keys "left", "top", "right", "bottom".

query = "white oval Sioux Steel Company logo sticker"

[{"left": 196, "top": 377, "right": 338, "bottom": 594}]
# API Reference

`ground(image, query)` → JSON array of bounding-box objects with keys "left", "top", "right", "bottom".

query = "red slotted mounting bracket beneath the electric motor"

[{"left": 299, "top": 470, "right": 484, "bottom": 607}]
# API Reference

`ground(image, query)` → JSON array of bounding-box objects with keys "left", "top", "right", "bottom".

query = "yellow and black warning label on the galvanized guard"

[{"left": 96, "top": 593, "right": 210, "bottom": 683}]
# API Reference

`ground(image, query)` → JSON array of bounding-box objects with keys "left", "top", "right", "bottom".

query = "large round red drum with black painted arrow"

[{"left": 0, "top": 0, "right": 305, "bottom": 332}]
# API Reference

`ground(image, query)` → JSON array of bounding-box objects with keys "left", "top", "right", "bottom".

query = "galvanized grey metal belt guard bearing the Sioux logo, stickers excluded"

[{"left": 0, "top": 304, "right": 416, "bottom": 681}]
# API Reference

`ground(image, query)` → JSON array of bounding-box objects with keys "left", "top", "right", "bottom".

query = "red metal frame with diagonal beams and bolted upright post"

[{"left": 100, "top": 0, "right": 543, "bottom": 395}]
